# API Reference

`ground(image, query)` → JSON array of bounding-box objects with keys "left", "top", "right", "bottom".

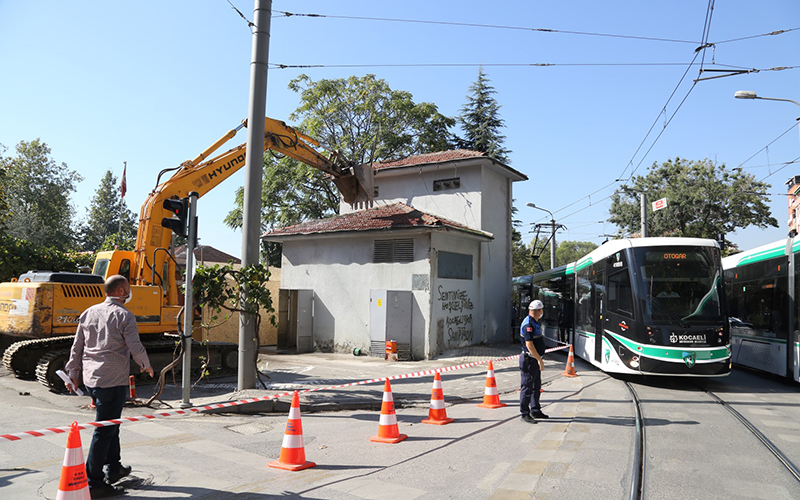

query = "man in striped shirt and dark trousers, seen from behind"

[{"left": 64, "top": 275, "right": 153, "bottom": 498}]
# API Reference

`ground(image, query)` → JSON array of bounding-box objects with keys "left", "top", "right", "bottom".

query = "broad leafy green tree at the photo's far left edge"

[{"left": 0, "top": 139, "right": 83, "bottom": 249}]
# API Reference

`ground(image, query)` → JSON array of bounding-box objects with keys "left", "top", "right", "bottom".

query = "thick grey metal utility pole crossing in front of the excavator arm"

[{"left": 237, "top": 0, "right": 272, "bottom": 391}]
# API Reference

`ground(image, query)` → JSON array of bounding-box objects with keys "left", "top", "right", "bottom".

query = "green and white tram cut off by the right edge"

[{"left": 722, "top": 238, "right": 800, "bottom": 382}]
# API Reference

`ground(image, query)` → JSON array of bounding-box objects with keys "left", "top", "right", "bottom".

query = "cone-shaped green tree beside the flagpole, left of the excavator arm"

[{"left": 81, "top": 170, "right": 137, "bottom": 251}]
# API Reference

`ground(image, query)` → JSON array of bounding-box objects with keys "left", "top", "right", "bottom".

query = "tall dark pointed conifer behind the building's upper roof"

[{"left": 458, "top": 66, "right": 511, "bottom": 163}]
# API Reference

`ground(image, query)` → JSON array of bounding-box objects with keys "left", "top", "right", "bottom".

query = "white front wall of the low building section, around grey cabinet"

[{"left": 281, "top": 231, "right": 431, "bottom": 359}]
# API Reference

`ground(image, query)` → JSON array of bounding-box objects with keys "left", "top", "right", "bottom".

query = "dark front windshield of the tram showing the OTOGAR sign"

[{"left": 634, "top": 247, "right": 724, "bottom": 326}]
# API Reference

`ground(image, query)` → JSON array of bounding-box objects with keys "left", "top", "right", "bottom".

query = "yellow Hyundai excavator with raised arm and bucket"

[{"left": 0, "top": 118, "right": 374, "bottom": 391}]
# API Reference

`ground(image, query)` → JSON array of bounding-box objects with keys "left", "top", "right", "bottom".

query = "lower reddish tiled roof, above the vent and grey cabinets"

[{"left": 262, "top": 203, "right": 492, "bottom": 238}]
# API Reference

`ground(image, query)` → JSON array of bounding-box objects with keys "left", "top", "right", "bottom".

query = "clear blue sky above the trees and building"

[{"left": 0, "top": 0, "right": 800, "bottom": 262}]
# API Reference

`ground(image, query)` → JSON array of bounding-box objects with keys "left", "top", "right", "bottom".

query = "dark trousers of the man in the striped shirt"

[{"left": 86, "top": 385, "right": 128, "bottom": 487}]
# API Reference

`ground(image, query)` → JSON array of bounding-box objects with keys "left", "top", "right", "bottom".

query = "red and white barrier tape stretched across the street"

[{"left": 0, "top": 347, "right": 540, "bottom": 442}]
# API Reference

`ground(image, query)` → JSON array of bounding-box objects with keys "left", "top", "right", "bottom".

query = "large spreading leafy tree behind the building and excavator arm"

[{"left": 225, "top": 75, "right": 455, "bottom": 265}]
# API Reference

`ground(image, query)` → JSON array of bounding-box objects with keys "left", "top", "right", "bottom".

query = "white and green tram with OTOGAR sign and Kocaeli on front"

[{"left": 515, "top": 238, "right": 731, "bottom": 377}]
